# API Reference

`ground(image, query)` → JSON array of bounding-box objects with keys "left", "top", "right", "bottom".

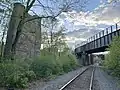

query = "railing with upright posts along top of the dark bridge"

[{"left": 75, "top": 21, "right": 120, "bottom": 48}]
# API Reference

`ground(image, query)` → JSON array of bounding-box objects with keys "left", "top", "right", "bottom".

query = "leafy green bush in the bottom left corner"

[{"left": 0, "top": 60, "right": 35, "bottom": 88}]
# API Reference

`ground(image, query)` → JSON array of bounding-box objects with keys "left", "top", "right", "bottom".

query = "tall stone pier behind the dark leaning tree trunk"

[{"left": 16, "top": 15, "right": 40, "bottom": 57}]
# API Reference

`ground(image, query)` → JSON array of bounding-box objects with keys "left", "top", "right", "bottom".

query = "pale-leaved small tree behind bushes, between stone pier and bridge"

[{"left": 42, "top": 23, "right": 67, "bottom": 56}]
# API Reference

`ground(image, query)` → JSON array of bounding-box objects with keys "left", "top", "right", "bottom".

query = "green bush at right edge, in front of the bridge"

[{"left": 104, "top": 37, "right": 120, "bottom": 77}]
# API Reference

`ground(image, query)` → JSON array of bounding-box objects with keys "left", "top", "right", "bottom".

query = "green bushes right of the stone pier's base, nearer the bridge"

[{"left": 31, "top": 51, "right": 77, "bottom": 78}]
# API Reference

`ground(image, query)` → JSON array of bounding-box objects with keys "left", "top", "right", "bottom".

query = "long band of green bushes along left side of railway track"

[{"left": 0, "top": 50, "right": 78, "bottom": 88}]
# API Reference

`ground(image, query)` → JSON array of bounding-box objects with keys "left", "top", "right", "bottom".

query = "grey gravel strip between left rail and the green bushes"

[{"left": 27, "top": 67, "right": 87, "bottom": 90}]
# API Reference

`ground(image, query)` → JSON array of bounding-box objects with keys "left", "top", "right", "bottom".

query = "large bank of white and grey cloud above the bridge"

[{"left": 59, "top": 1, "right": 120, "bottom": 48}]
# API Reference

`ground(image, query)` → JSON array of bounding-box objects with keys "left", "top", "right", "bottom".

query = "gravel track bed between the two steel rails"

[{"left": 64, "top": 68, "right": 92, "bottom": 90}]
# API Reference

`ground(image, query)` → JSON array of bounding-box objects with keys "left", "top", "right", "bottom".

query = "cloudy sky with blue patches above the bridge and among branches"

[{"left": 28, "top": 0, "right": 120, "bottom": 49}]
